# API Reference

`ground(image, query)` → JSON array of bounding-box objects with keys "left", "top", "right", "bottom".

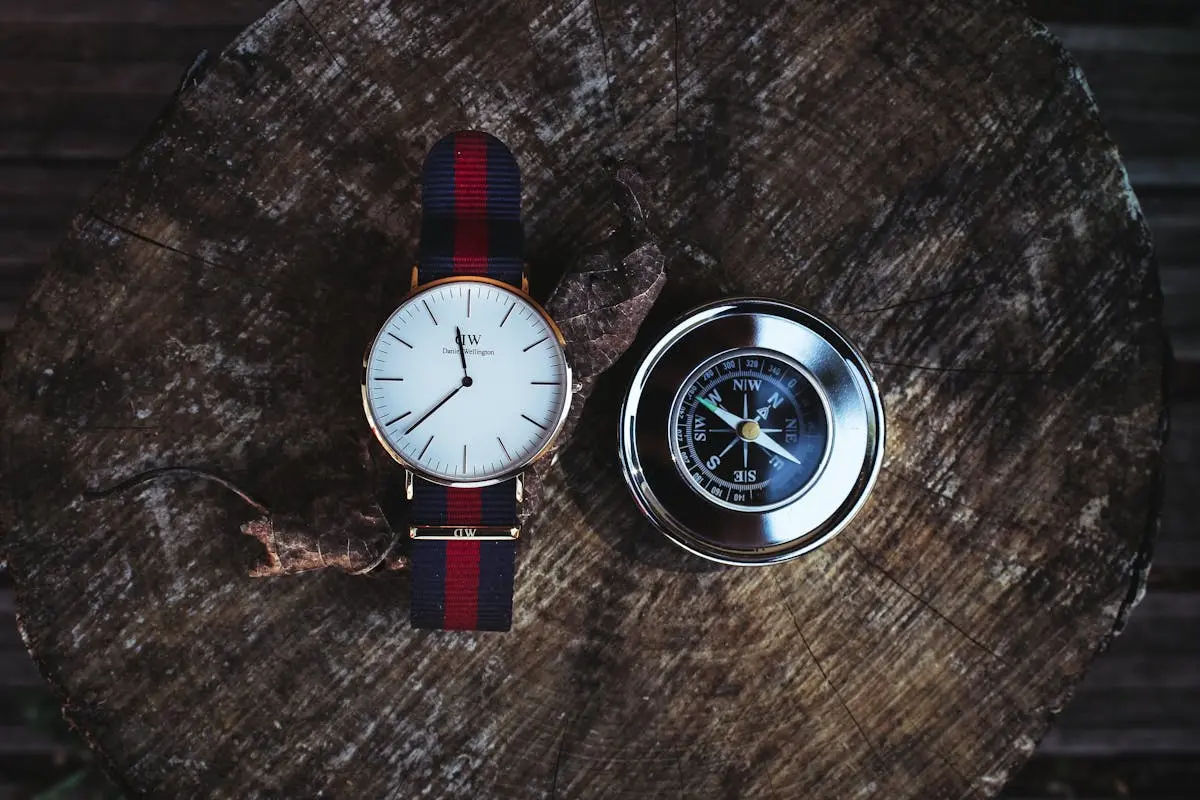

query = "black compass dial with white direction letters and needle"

[{"left": 671, "top": 351, "right": 829, "bottom": 511}]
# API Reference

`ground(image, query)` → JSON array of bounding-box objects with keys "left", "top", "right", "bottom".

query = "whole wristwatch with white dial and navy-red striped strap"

[{"left": 362, "top": 131, "right": 571, "bottom": 631}]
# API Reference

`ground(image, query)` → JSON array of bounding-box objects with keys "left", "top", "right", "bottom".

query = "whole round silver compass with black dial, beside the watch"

[{"left": 620, "top": 297, "right": 884, "bottom": 565}]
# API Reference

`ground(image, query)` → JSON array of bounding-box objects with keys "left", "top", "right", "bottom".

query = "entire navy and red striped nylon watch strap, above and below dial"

[{"left": 409, "top": 131, "right": 524, "bottom": 631}]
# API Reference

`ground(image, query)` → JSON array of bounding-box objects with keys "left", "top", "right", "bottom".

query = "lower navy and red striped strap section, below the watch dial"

[{"left": 409, "top": 479, "right": 517, "bottom": 631}]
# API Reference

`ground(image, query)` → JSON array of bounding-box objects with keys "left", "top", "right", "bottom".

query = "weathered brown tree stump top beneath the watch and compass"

[{"left": 2, "top": 0, "right": 1165, "bottom": 800}]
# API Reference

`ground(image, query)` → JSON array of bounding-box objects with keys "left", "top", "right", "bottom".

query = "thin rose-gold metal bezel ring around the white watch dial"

[{"left": 359, "top": 275, "right": 575, "bottom": 488}]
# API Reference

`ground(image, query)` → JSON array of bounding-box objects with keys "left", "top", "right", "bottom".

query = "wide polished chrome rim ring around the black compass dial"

[{"left": 620, "top": 297, "right": 884, "bottom": 565}]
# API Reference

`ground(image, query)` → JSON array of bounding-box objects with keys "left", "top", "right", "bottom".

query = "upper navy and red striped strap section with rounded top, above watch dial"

[{"left": 418, "top": 131, "right": 524, "bottom": 287}]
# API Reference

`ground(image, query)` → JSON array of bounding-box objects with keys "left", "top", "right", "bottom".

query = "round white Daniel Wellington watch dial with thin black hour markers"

[{"left": 362, "top": 278, "right": 570, "bottom": 483}]
